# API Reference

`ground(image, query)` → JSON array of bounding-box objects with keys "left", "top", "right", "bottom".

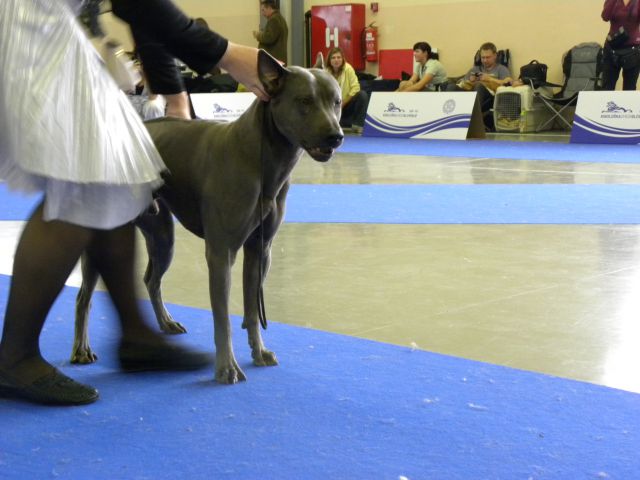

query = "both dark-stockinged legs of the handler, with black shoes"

[{"left": 0, "top": 205, "right": 210, "bottom": 405}]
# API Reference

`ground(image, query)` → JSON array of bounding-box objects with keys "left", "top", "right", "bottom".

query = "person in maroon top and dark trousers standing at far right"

[{"left": 602, "top": 0, "right": 640, "bottom": 90}]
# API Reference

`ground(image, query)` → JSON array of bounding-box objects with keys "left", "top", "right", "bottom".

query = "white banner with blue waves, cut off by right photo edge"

[{"left": 571, "top": 91, "right": 640, "bottom": 144}]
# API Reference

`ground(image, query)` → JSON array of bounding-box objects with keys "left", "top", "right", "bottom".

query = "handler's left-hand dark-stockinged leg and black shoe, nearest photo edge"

[{"left": 0, "top": 205, "right": 98, "bottom": 405}]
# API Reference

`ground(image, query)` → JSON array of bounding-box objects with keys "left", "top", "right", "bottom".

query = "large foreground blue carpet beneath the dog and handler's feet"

[{"left": 0, "top": 276, "right": 640, "bottom": 480}]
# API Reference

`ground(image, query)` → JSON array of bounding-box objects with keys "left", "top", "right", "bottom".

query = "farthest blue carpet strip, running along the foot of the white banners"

[{"left": 340, "top": 136, "right": 640, "bottom": 163}]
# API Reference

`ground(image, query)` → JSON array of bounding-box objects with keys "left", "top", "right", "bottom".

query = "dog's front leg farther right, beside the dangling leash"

[{"left": 242, "top": 232, "right": 278, "bottom": 367}]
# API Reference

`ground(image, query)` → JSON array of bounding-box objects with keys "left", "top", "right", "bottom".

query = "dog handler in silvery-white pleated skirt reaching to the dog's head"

[{"left": 0, "top": 0, "right": 267, "bottom": 405}]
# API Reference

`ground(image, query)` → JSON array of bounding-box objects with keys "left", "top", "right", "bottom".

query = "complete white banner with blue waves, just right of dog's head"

[{"left": 363, "top": 92, "right": 476, "bottom": 140}]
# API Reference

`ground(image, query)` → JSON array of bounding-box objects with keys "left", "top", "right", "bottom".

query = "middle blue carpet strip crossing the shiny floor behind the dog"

[{"left": 0, "top": 184, "right": 640, "bottom": 224}]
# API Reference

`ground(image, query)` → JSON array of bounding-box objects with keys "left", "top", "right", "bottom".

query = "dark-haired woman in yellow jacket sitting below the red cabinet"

[{"left": 326, "top": 47, "right": 369, "bottom": 134}]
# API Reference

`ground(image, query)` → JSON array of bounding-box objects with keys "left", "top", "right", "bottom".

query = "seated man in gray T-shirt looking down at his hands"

[{"left": 447, "top": 42, "right": 513, "bottom": 125}]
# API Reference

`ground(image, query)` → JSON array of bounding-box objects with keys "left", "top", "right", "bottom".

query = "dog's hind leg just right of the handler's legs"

[{"left": 136, "top": 200, "right": 187, "bottom": 334}]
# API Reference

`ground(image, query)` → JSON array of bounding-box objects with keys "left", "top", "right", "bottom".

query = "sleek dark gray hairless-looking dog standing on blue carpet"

[{"left": 72, "top": 51, "right": 343, "bottom": 383}]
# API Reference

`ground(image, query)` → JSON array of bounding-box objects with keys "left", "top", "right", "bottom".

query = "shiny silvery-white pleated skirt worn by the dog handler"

[{"left": 0, "top": 0, "right": 164, "bottom": 229}]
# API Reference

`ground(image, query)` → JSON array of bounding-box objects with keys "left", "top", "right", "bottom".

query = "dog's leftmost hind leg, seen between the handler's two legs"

[{"left": 71, "top": 253, "right": 99, "bottom": 364}]
